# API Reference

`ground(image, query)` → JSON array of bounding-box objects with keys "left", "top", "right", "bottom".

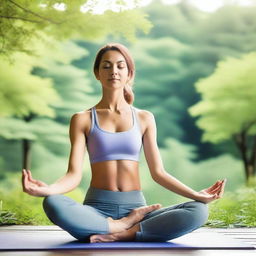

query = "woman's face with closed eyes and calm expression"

[{"left": 96, "top": 50, "right": 129, "bottom": 88}]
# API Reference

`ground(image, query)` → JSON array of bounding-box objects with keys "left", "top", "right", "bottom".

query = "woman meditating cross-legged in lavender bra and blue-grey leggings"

[{"left": 22, "top": 44, "right": 226, "bottom": 242}]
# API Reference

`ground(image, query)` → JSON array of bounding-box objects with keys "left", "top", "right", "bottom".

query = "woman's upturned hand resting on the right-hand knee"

[{"left": 196, "top": 179, "right": 227, "bottom": 204}]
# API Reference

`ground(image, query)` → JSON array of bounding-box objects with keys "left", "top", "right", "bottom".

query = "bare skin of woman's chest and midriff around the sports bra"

[{"left": 77, "top": 105, "right": 147, "bottom": 191}]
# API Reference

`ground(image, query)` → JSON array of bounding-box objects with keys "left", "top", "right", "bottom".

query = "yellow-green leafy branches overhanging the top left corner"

[{"left": 0, "top": 0, "right": 151, "bottom": 57}]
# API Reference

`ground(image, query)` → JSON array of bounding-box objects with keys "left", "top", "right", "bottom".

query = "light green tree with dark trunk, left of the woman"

[{"left": 0, "top": 39, "right": 89, "bottom": 168}]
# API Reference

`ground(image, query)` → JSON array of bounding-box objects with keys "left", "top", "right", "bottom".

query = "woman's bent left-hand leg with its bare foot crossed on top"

[{"left": 43, "top": 195, "right": 161, "bottom": 241}]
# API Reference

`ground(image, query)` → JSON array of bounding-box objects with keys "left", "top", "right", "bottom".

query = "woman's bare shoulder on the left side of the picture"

[{"left": 70, "top": 109, "right": 91, "bottom": 134}]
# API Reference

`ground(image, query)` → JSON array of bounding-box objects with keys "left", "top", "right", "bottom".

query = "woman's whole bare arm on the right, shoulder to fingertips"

[{"left": 143, "top": 111, "right": 226, "bottom": 203}]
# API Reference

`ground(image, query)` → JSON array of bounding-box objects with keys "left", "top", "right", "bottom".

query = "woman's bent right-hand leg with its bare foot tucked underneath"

[{"left": 90, "top": 201, "right": 208, "bottom": 243}]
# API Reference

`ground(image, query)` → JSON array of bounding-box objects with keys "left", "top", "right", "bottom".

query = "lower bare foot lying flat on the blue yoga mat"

[{"left": 90, "top": 225, "right": 140, "bottom": 243}]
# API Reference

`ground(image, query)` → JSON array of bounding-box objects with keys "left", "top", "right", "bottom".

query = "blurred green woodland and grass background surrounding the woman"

[{"left": 0, "top": 0, "right": 256, "bottom": 227}]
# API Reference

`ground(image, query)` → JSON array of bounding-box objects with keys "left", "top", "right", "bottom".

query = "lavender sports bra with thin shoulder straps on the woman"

[{"left": 86, "top": 106, "right": 142, "bottom": 163}]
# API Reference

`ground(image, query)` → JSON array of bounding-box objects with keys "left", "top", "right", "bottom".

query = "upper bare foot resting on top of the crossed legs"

[{"left": 108, "top": 204, "right": 161, "bottom": 233}]
